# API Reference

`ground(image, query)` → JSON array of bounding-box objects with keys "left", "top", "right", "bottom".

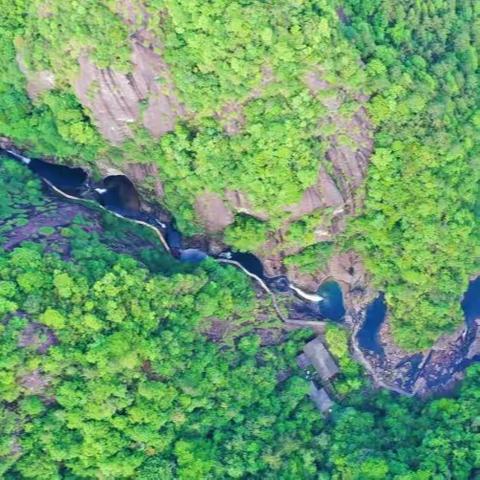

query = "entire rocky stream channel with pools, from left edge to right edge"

[{"left": 0, "top": 145, "right": 480, "bottom": 395}]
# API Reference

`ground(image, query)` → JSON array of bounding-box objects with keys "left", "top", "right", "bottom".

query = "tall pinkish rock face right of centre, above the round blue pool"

[{"left": 255, "top": 70, "right": 373, "bottom": 284}]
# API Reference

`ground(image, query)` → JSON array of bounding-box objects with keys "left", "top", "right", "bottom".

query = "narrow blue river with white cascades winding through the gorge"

[{"left": 0, "top": 148, "right": 480, "bottom": 394}]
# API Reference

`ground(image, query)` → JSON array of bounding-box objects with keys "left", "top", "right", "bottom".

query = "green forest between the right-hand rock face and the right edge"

[{"left": 344, "top": 0, "right": 480, "bottom": 349}]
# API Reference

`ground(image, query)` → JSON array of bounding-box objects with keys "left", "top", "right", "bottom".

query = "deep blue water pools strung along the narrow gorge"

[{"left": 5, "top": 148, "right": 480, "bottom": 340}]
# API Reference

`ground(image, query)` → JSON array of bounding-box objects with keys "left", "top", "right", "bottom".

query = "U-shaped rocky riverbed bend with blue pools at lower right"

[{"left": 352, "top": 277, "right": 480, "bottom": 395}]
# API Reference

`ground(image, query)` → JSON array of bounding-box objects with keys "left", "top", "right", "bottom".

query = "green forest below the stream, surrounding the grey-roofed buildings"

[{"left": 0, "top": 158, "right": 480, "bottom": 480}]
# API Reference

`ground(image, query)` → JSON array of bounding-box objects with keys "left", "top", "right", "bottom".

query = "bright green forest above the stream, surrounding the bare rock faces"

[{"left": 0, "top": 0, "right": 480, "bottom": 349}]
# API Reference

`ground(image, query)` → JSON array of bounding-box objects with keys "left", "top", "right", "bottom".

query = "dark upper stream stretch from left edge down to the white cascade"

[{"left": 0, "top": 148, "right": 325, "bottom": 326}]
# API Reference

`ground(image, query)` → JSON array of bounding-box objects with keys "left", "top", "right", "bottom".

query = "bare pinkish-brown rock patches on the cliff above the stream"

[{"left": 17, "top": 0, "right": 372, "bottom": 289}]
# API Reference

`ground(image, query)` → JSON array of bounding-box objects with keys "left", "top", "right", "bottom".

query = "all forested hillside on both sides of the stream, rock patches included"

[{"left": 0, "top": 0, "right": 480, "bottom": 480}]
